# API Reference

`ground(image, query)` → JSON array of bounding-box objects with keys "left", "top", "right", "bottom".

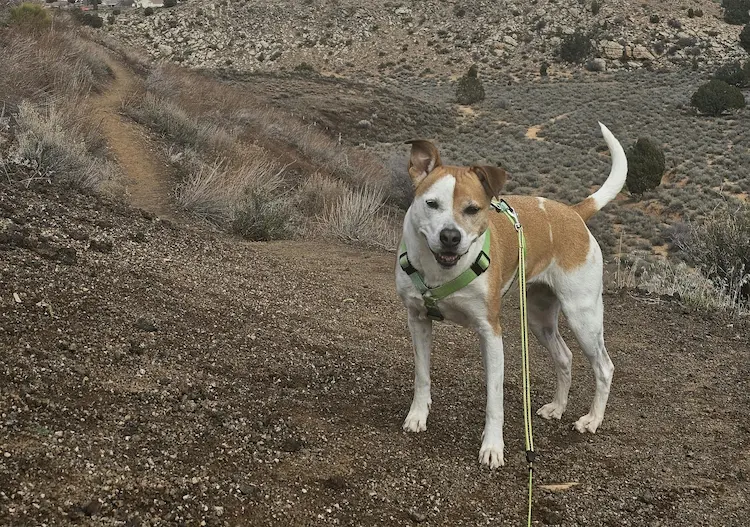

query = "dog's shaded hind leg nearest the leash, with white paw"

[{"left": 528, "top": 284, "right": 573, "bottom": 419}]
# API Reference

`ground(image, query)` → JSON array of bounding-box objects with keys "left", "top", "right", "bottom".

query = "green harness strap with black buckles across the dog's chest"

[{"left": 398, "top": 229, "right": 490, "bottom": 320}]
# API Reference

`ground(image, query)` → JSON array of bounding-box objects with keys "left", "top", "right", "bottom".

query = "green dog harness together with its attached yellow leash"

[{"left": 398, "top": 199, "right": 536, "bottom": 527}]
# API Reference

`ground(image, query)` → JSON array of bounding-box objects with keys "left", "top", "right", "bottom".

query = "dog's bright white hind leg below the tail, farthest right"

[{"left": 562, "top": 279, "right": 615, "bottom": 433}]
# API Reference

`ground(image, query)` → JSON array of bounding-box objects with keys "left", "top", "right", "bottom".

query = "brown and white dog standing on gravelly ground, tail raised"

[{"left": 396, "top": 123, "right": 627, "bottom": 468}]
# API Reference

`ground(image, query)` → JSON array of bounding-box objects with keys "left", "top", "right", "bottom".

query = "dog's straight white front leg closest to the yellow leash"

[{"left": 479, "top": 327, "right": 505, "bottom": 468}]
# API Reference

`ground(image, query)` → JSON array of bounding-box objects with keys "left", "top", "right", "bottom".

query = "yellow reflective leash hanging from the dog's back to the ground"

[{"left": 492, "top": 200, "right": 536, "bottom": 527}]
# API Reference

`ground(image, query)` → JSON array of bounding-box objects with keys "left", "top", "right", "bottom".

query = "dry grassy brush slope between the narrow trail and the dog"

[{"left": 126, "top": 66, "right": 406, "bottom": 250}]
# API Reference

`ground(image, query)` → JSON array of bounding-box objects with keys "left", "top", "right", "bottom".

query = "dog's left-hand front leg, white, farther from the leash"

[{"left": 404, "top": 309, "right": 432, "bottom": 432}]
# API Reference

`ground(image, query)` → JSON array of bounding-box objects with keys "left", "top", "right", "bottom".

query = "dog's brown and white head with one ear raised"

[{"left": 408, "top": 140, "right": 507, "bottom": 268}]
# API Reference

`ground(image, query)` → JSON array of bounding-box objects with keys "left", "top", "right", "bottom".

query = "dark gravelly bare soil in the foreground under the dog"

[{"left": 0, "top": 52, "right": 750, "bottom": 527}]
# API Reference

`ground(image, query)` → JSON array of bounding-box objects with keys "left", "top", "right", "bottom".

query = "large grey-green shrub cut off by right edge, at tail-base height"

[{"left": 675, "top": 205, "right": 750, "bottom": 301}]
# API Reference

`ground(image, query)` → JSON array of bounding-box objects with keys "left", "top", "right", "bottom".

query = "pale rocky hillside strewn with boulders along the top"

[{"left": 105, "top": 0, "right": 747, "bottom": 76}]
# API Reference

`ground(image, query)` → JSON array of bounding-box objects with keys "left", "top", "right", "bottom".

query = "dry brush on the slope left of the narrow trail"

[{"left": 0, "top": 8, "right": 116, "bottom": 188}]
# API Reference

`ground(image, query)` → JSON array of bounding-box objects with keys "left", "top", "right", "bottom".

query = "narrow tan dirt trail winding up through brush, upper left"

[{"left": 93, "top": 53, "right": 178, "bottom": 220}]
